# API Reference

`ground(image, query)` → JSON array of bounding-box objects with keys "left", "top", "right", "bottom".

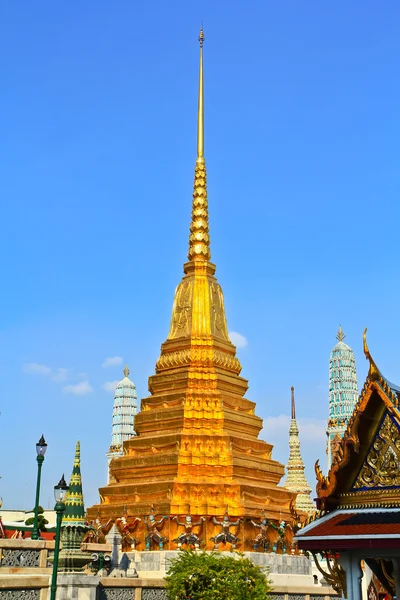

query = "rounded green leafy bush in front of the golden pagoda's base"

[{"left": 165, "top": 550, "right": 272, "bottom": 600}]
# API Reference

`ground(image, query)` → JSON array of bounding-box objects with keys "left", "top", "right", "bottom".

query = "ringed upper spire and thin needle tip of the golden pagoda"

[{"left": 188, "top": 29, "right": 211, "bottom": 261}]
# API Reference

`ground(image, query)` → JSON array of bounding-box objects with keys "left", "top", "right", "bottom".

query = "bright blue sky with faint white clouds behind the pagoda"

[{"left": 0, "top": 0, "right": 400, "bottom": 508}]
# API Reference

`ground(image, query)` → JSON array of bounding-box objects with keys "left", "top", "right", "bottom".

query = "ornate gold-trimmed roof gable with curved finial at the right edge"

[{"left": 315, "top": 330, "right": 400, "bottom": 511}]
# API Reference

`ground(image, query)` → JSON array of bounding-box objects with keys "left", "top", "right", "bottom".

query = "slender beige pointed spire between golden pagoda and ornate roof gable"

[{"left": 285, "top": 387, "right": 316, "bottom": 514}]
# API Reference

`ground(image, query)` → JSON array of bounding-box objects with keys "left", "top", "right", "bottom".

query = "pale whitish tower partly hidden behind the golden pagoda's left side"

[{"left": 106, "top": 365, "right": 137, "bottom": 480}]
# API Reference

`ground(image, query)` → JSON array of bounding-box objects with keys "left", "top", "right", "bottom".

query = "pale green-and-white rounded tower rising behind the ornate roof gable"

[{"left": 326, "top": 327, "right": 358, "bottom": 469}]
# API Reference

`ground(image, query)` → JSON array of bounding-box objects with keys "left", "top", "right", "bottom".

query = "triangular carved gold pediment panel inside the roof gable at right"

[{"left": 353, "top": 414, "right": 400, "bottom": 489}]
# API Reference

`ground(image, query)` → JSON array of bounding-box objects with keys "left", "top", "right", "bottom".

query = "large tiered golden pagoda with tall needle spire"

[{"left": 88, "top": 30, "right": 295, "bottom": 549}]
